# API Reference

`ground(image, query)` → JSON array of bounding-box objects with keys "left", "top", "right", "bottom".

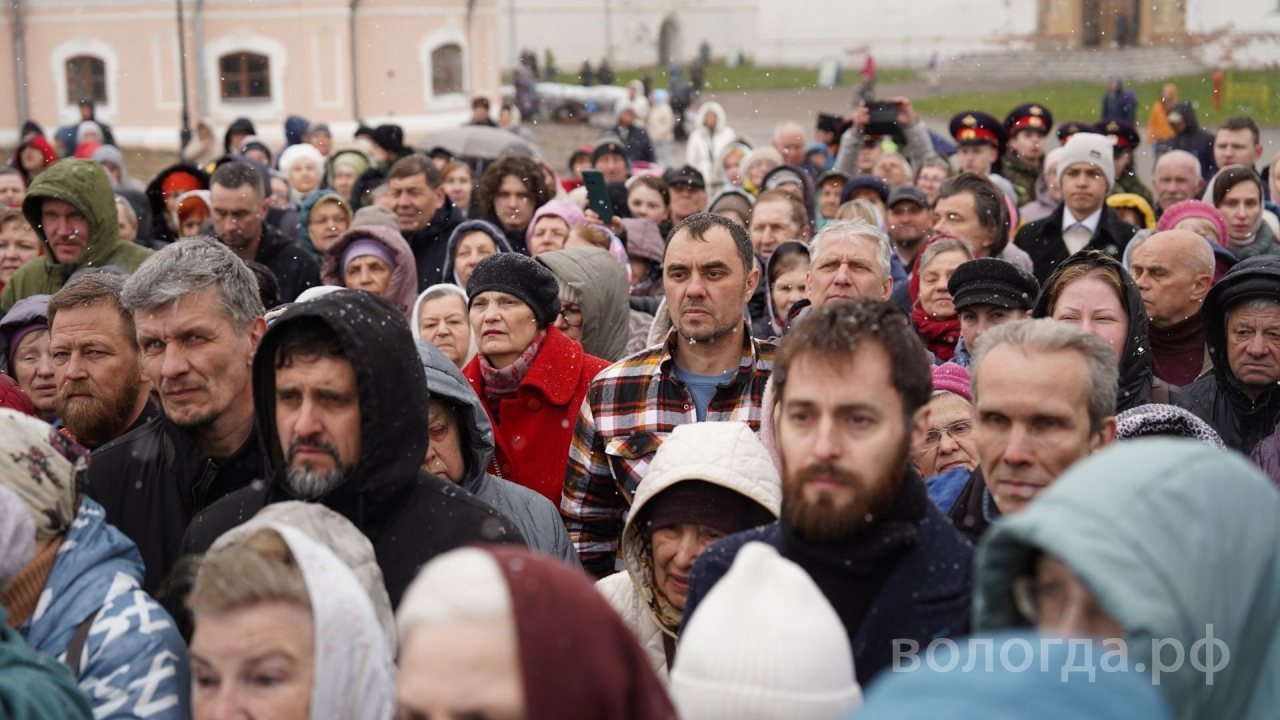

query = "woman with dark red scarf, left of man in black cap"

[{"left": 910, "top": 236, "right": 973, "bottom": 360}]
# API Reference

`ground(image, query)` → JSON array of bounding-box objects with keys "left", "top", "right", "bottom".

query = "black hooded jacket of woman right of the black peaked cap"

[{"left": 1032, "top": 250, "right": 1190, "bottom": 414}]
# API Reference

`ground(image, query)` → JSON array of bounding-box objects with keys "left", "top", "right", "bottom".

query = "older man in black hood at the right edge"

[{"left": 1185, "top": 255, "right": 1280, "bottom": 454}]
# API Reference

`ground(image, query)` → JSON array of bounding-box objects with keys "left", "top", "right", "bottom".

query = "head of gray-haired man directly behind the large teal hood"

[{"left": 947, "top": 318, "right": 1120, "bottom": 544}]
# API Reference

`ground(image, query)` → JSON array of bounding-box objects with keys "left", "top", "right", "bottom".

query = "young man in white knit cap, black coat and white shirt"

[{"left": 1014, "top": 132, "right": 1138, "bottom": 284}]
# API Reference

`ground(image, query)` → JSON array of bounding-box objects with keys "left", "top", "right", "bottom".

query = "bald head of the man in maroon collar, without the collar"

[{"left": 1129, "top": 229, "right": 1213, "bottom": 328}]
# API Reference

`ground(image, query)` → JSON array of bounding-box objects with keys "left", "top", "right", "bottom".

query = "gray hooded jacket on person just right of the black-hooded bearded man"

[{"left": 417, "top": 341, "right": 580, "bottom": 568}]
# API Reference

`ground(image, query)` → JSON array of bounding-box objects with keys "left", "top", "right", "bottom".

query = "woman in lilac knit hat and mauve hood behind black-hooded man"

[{"left": 320, "top": 225, "right": 417, "bottom": 318}]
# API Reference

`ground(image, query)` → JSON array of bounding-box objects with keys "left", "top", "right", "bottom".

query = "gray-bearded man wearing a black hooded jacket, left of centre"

[{"left": 184, "top": 291, "right": 524, "bottom": 605}]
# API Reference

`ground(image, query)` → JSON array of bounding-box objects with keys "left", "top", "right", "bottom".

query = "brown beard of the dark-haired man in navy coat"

[{"left": 782, "top": 434, "right": 911, "bottom": 542}]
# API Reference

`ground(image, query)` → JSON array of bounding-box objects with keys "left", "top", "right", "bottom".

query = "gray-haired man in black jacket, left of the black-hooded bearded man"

[{"left": 88, "top": 237, "right": 266, "bottom": 592}]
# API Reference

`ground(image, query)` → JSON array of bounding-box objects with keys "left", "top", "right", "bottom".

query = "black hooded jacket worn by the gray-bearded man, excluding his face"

[{"left": 186, "top": 291, "right": 524, "bottom": 605}]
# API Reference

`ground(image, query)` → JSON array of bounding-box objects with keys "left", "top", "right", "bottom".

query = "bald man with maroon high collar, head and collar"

[{"left": 1129, "top": 229, "right": 1213, "bottom": 387}]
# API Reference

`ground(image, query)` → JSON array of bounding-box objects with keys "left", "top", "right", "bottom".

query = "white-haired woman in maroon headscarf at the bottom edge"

[{"left": 396, "top": 546, "right": 676, "bottom": 720}]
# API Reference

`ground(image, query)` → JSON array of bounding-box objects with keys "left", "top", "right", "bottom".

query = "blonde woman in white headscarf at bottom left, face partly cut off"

[{"left": 187, "top": 523, "right": 396, "bottom": 720}]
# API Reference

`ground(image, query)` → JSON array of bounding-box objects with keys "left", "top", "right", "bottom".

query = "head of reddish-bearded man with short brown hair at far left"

[{"left": 49, "top": 273, "right": 155, "bottom": 450}]
